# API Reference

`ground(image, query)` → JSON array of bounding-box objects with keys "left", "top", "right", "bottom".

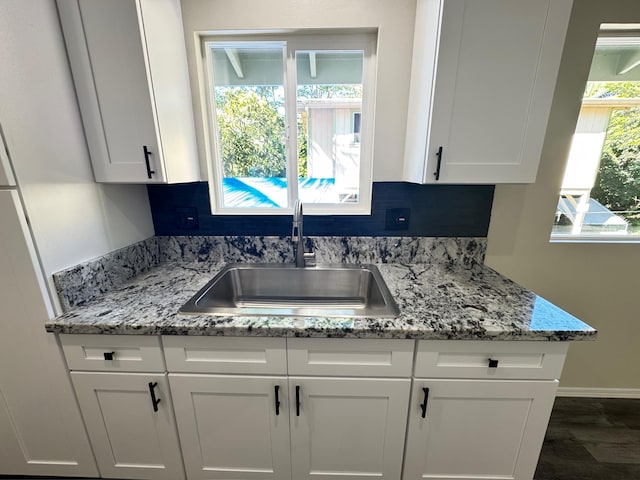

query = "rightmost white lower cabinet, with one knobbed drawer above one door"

[{"left": 403, "top": 340, "right": 568, "bottom": 480}]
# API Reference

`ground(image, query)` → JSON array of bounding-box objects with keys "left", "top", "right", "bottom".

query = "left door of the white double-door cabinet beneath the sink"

[{"left": 169, "top": 374, "right": 291, "bottom": 480}]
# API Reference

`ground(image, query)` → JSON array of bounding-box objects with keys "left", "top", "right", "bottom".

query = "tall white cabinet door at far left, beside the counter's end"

[{"left": 0, "top": 190, "right": 97, "bottom": 477}]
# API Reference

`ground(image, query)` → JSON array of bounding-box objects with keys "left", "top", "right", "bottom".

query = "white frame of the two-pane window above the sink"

[{"left": 196, "top": 30, "right": 377, "bottom": 215}]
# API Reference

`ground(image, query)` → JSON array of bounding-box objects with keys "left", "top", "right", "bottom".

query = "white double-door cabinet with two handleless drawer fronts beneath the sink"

[{"left": 164, "top": 338, "right": 413, "bottom": 480}]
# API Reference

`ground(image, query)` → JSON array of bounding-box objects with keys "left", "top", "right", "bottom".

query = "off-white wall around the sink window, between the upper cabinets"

[{"left": 181, "top": 0, "right": 416, "bottom": 181}]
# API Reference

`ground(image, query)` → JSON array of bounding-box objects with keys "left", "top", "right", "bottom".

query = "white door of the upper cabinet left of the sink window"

[{"left": 74, "top": 0, "right": 164, "bottom": 182}]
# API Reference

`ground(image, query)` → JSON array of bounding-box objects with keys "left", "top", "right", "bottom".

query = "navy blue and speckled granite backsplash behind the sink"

[{"left": 53, "top": 182, "right": 494, "bottom": 310}]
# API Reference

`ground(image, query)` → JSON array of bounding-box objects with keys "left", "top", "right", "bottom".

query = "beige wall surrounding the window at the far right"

[{"left": 486, "top": 0, "right": 640, "bottom": 388}]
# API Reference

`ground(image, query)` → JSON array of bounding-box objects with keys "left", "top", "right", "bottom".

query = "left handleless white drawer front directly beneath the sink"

[{"left": 162, "top": 336, "right": 287, "bottom": 374}]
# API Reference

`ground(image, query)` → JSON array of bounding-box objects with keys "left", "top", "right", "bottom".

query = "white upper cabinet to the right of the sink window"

[{"left": 404, "top": 0, "right": 572, "bottom": 184}]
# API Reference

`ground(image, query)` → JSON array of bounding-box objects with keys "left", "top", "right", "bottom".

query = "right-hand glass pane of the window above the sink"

[{"left": 296, "top": 51, "right": 366, "bottom": 204}]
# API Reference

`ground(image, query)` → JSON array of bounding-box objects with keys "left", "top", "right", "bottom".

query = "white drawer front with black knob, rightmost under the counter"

[{"left": 414, "top": 340, "right": 568, "bottom": 380}]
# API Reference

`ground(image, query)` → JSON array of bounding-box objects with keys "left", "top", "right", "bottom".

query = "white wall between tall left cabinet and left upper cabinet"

[{"left": 0, "top": 0, "right": 154, "bottom": 314}]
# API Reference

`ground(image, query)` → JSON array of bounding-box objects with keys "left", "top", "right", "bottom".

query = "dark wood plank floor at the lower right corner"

[{"left": 535, "top": 397, "right": 640, "bottom": 480}]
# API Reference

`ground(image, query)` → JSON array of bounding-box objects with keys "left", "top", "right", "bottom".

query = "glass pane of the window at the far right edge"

[{"left": 552, "top": 29, "right": 640, "bottom": 237}]
